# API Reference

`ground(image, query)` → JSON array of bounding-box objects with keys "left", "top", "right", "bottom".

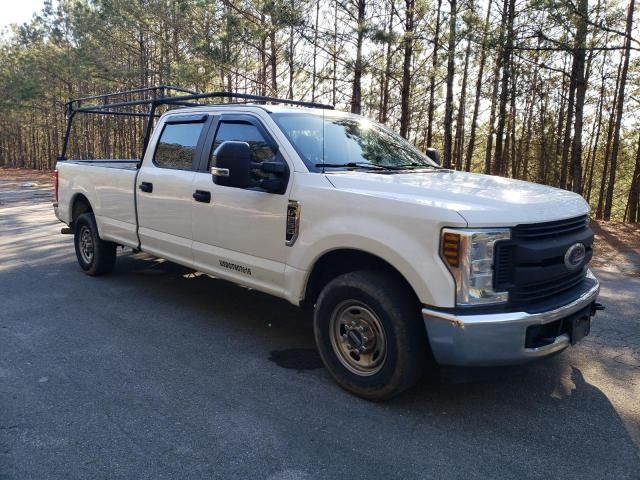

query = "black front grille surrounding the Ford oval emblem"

[{"left": 493, "top": 215, "right": 593, "bottom": 305}]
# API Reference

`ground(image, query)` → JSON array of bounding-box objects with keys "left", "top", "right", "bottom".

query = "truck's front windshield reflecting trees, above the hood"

[{"left": 272, "top": 112, "right": 436, "bottom": 172}]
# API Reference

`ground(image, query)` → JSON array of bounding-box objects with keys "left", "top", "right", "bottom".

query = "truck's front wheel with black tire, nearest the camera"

[{"left": 313, "top": 271, "right": 429, "bottom": 400}]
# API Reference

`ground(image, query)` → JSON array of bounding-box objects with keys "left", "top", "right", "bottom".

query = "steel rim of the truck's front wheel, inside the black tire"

[{"left": 330, "top": 300, "right": 387, "bottom": 376}]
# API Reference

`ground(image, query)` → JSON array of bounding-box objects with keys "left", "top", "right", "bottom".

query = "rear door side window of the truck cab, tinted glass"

[{"left": 153, "top": 122, "right": 204, "bottom": 170}]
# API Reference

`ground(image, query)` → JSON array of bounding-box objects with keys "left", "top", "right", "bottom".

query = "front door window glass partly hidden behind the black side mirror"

[{"left": 210, "top": 121, "right": 277, "bottom": 181}]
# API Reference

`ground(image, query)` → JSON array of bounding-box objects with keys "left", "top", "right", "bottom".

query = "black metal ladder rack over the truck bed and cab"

[{"left": 58, "top": 85, "right": 333, "bottom": 161}]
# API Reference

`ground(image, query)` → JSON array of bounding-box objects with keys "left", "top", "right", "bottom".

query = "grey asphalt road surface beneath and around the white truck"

[{"left": 0, "top": 182, "right": 640, "bottom": 480}]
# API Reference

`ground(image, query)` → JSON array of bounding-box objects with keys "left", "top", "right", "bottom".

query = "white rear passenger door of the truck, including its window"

[{"left": 136, "top": 114, "right": 210, "bottom": 266}]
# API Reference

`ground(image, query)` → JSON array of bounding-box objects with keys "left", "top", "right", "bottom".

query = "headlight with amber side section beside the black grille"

[{"left": 440, "top": 228, "right": 511, "bottom": 306}]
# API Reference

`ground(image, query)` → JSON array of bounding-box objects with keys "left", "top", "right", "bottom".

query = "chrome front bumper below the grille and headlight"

[{"left": 422, "top": 272, "right": 600, "bottom": 366}]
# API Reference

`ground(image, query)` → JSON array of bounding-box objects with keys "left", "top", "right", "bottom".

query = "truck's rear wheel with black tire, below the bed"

[{"left": 73, "top": 213, "right": 117, "bottom": 276}]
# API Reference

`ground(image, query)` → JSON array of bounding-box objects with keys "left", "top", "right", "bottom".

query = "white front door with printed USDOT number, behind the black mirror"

[{"left": 192, "top": 115, "right": 288, "bottom": 295}]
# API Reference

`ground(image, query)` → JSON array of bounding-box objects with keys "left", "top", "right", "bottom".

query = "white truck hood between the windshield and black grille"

[{"left": 326, "top": 170, "right": 589, "bottom": 227}]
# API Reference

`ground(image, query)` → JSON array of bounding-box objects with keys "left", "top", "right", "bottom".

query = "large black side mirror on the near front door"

[{"left": 211, "top": 141, "right": 251, "bottom": 188}]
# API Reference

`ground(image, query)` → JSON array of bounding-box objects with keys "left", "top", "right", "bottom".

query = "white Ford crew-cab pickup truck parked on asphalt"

[{"left": 54, "top": 88, "right": 602, "bottom": 399}]
